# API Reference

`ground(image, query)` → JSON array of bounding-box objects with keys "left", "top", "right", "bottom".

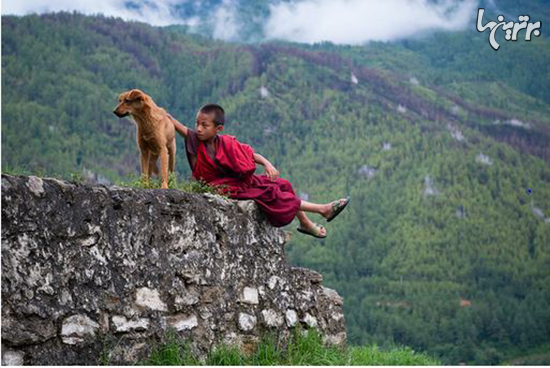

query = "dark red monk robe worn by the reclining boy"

[{"left": 185, "top": 128, "right": 301, "bottom": 227}]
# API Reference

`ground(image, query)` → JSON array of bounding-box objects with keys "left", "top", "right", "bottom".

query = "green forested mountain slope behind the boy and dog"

[{"left": 2, "top": 13, "right": 550, "bottom": 364}]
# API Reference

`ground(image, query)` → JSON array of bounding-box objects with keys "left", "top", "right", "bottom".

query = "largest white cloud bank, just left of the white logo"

[{"left": 264, "top": 0, "right": 477, "bottom": 44}]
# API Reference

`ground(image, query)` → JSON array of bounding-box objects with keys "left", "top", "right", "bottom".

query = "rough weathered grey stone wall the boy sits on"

[{"left": 2, "top": 175, "right": 346, "bottom": 365}]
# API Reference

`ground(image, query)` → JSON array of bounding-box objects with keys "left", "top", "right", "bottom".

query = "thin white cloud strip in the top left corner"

[{"left": 2, "top": 0, "right": 188, "bottom": 26}]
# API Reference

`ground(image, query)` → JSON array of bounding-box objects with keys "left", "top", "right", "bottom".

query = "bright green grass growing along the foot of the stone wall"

[{"left": 137, "top": 326, "right": 441, "bottom": 366}]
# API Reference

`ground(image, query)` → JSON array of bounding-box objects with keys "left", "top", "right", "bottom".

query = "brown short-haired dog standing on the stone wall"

[{"left": 113, "top": 89, "right": 176, "bottom": 189}]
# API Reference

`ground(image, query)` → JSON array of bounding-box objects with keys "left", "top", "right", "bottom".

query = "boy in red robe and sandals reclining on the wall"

[{"left": 170, "top": 104, "right": 350, "bottom": 238}]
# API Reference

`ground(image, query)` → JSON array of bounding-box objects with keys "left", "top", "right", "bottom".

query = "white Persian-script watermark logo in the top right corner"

[{"left": 476, "top": 8, "right": 542, "bottom": 51}]
